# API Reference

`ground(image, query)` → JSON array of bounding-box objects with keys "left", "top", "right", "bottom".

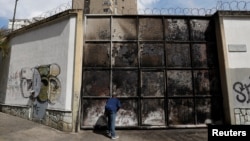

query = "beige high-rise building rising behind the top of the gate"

[{"left": 72, "top": 0, "right": 137, "bottom": 14}]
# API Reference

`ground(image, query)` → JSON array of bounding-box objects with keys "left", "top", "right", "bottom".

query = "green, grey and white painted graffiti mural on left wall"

[{"left": 21, "top": 64, "right": 61, "bottom": 119}]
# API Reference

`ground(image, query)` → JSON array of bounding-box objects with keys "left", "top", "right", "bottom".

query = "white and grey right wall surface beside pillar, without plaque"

[{"left": 223, "top": 16, "right": 250, "bottom": 118}]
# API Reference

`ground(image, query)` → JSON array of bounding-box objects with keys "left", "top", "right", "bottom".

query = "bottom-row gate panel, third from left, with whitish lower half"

[{"left": 141, "top": 99, "right": 165, "bottom": 126}]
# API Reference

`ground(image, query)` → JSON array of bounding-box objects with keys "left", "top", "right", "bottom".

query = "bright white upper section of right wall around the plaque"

[{"left": 223, "top": 17, "right": 250, "bottom": 68}]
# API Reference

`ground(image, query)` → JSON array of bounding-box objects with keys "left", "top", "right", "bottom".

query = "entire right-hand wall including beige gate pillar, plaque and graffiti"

[{"left": 216, "top": 12, "right": 250, "bottom": 124}]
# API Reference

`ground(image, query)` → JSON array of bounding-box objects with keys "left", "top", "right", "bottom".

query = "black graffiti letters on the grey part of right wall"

[{"left": 233, "top": 77, "right": 250, "bottom": 104}]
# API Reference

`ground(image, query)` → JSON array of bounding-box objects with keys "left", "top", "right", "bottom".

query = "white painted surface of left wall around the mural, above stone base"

[{"left": 4, "top": 17, "right": 76, "bottom": 111}]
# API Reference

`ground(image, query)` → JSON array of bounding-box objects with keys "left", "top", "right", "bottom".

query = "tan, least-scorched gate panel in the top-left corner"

[{"left": 86, "top": 17, "right": 111, "bottom": 40}]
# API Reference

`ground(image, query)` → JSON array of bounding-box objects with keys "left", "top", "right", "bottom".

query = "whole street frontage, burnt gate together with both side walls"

[{"left": 0, "top": 9, "right": 250, "bottom": 132}]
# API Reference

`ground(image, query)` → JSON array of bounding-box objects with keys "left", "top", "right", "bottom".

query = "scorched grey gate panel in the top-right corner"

[{"left": 190, "top": 19, "right": 210, "bottom": 41}]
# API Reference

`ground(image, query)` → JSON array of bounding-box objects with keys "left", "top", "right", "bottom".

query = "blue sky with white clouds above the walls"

[{"left": 0, "top": 0, "right": 248, "bottom": 28}]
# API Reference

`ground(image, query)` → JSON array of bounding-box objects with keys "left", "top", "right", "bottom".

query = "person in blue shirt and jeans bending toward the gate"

[{"left": 105, "top": 93, "right": 121, "bottom": 139}]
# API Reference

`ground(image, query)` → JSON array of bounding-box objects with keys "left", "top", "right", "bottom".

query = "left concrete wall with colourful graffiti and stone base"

[{"left": 0, "top": 11, "right": 76, "bottom": 131}]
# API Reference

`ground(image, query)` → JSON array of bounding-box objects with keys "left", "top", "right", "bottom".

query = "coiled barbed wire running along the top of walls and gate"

[{"left": 12, "top": 0, "right": 250, "bottom": 30}]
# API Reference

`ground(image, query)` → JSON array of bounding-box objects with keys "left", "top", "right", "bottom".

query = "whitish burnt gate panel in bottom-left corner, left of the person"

[{"left": 81, "top": 99, "right": 107, "bottom": 127}]
